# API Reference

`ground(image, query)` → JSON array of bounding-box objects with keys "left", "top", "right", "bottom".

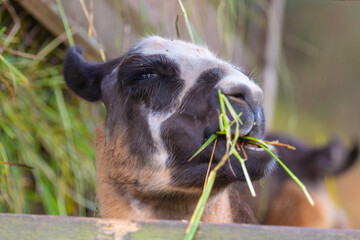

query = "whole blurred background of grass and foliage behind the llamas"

[{"left": 0, "top": 0, "right": 360, "bottom": 228}]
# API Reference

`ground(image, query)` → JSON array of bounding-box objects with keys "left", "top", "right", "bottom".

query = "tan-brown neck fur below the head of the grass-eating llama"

[{"left": 96, "top": 126, "right": 253, "bottom": 223}]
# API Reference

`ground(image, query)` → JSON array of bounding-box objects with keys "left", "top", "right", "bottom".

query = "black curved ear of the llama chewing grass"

[{"left": 64, "top": 46, "right": 120, "bottom": 102}]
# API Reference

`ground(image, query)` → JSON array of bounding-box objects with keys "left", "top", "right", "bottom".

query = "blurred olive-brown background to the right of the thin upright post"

[{"left": 273, "top": 1, "right": 360, "bottom": 144}]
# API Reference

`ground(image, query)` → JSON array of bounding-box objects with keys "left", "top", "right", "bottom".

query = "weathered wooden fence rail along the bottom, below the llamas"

[{"left": 0, "top": 214, "right": 360, "bottom": 240}]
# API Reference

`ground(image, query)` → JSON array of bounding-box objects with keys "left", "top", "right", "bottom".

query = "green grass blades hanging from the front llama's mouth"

[{"left": 185, "top": 90, "right": 314, "bottom": 240}]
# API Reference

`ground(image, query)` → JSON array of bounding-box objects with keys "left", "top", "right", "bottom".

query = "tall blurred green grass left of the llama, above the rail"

[{"left": 0, "top": 2, "right": 103, "bottom": 215}]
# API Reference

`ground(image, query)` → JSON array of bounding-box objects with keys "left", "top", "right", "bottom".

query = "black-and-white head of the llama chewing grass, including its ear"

[{"left": 64, "top": 36, "right": 274, "bottom": 197}]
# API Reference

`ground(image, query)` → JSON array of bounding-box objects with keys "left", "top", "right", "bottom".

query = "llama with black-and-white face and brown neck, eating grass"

[{"left": 64, "top": 36, "right": 275, "bottom": 222}]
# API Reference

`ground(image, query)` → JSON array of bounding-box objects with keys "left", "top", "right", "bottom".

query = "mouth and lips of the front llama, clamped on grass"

[{"left": 203, "top": 91, "right": 273, "bottom": 177}]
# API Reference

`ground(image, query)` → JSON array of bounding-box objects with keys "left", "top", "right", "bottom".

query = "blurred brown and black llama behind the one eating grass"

[{"left": 264, "top": 134, "right": 359, "bottom": 228}]
